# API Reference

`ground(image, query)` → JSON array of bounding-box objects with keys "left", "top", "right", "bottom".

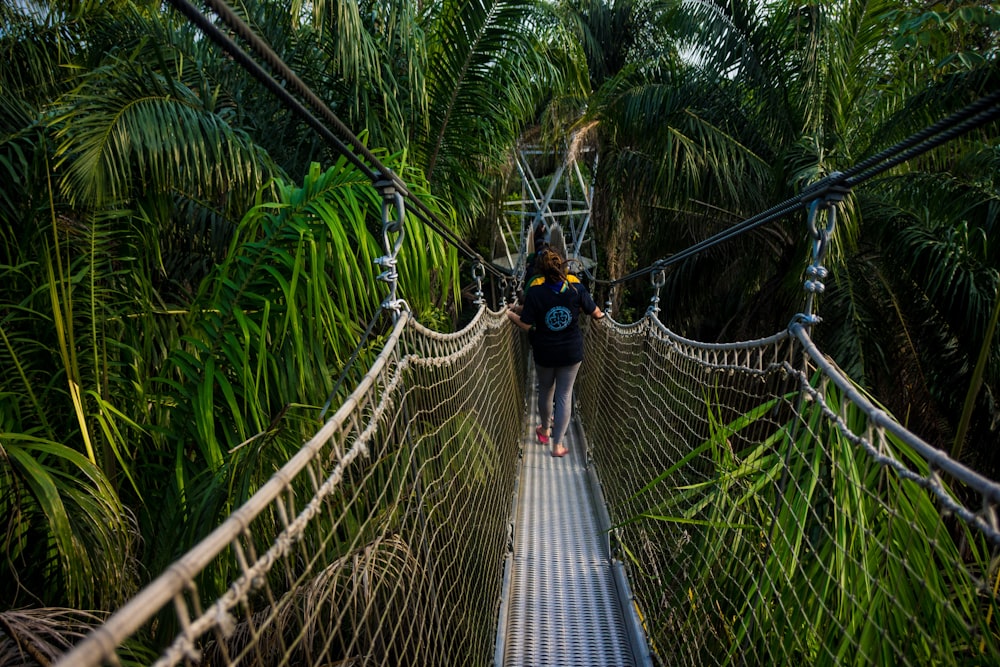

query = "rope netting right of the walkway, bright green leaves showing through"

[{"left": 577, "top": 315, "right": 1000, "bottom": 665}]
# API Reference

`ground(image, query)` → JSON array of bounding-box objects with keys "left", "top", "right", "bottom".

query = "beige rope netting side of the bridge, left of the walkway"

[{"left": 58, "top": 308, "right": 526, "bottom": 667}]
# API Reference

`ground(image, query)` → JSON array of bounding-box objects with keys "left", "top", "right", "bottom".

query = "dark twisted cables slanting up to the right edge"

[{"left": 584, "top": 92, "right": 1000, "bottom": 286}]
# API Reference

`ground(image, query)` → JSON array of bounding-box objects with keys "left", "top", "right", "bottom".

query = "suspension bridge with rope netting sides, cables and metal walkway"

[{"left": 48, "top": 0, "right": 1000, "bottom": 667}]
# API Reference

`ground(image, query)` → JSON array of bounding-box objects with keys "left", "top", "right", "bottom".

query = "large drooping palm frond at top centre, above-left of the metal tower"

[{"left": 412, "top": 0, "right": 562, "bottom": 220}]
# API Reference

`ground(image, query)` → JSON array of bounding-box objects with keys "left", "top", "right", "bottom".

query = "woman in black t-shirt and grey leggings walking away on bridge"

[{"left": 507, "top": 248, "right": 604, "bottom": 456}]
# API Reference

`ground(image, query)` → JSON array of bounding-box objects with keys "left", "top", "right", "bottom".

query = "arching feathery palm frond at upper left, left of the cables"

[{"left": 52, "top": 62, "right": 265, "bottom": 206}]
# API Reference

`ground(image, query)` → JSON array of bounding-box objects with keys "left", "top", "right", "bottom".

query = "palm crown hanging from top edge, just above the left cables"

[{"left": 260, "top": 0, "right": 572, "bottom": 224}]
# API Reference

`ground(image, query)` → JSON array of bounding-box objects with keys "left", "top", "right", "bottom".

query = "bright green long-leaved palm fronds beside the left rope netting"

[{"left": 141, "top": 151, "right": 458, "bottom": 568}]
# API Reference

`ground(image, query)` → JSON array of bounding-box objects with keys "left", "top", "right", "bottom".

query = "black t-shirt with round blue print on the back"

[{"left": 521, "top": 275, "right": 597, "bottom": 368}]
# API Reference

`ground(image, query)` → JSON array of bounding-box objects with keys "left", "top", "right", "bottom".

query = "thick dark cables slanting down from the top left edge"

[{"left": 168, "top": 0, "right": 510, "bottom": 277}]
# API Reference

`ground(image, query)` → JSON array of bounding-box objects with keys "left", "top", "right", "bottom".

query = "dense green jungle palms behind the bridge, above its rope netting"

[{"left": 0, "top": 0, "right": 1000, "bottom": 656}]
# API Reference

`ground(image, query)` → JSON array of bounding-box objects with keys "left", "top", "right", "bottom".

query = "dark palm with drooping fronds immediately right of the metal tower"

[{"left": 559, "top": 0, "right": 769, "bottom": 320}]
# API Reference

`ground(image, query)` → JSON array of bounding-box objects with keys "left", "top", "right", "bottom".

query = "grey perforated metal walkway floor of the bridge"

[{"left": 495, "top": 374, "right": 650, "bottom": 667}]
